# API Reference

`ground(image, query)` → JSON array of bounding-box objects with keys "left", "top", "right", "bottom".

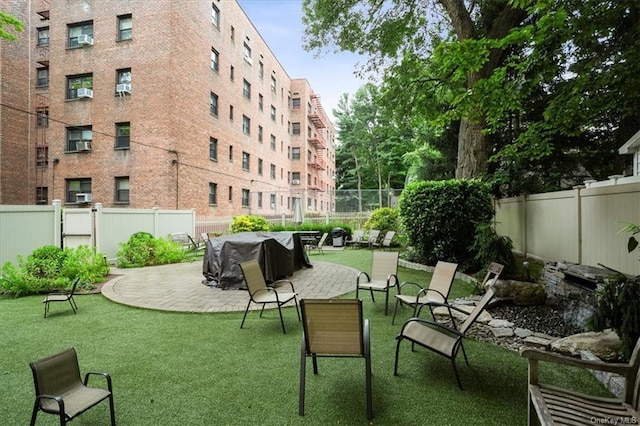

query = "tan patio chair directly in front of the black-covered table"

[{"left": 240, "top": 260, "right": 300, "bottom": 334}]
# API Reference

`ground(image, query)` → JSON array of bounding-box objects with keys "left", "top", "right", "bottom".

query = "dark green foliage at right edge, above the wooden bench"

[{"left": 590, "top": 274, "right": 640, "bottom": 360}]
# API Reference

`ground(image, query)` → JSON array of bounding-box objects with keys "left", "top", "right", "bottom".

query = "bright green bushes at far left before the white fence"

[{"left": 0, "top": 245, "right": 109, "bottom": 296}]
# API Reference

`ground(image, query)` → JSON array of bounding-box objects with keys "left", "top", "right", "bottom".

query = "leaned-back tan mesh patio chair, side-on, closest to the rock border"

[{"left": 393, "top": 287, "right": 495, "bottom": 390}]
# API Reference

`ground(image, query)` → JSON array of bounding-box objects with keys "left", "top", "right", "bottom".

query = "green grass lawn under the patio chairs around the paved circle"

[{"left": 0, "top": 250, "right": 603, "bottom": 426}]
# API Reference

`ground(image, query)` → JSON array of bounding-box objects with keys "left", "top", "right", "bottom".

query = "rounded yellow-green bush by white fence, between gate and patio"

[{"left": 116, "top": 232, "right": 189, "bottom": 268}]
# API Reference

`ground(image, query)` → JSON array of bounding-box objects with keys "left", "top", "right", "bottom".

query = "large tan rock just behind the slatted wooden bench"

[{"left": 551, "top": 329, "right": 622, "bottom": 361}]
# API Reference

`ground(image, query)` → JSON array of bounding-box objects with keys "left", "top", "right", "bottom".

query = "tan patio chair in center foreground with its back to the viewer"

[{"left": 298, "top": 299, "right": 373, "bottom": 420}]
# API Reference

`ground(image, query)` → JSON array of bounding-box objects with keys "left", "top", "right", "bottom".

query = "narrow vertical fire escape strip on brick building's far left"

[{"left": 34, "top": 0, "right": 50, "bottom": 204}]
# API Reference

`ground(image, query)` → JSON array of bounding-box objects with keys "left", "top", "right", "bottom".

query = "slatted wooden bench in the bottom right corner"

[{"left": 520, "top": 340, "right": 640, "bottom": 425}]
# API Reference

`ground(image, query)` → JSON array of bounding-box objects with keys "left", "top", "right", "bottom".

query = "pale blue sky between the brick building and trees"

[{"left": 238, "top": 0, "right": 366, "bottom": 123}]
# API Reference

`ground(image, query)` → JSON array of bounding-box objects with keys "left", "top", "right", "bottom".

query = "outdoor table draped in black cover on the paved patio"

[{"left": 202, "top": 232, "right": 312, "bottom": 290}]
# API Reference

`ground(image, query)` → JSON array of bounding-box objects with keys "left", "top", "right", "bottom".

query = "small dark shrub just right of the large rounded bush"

[{"left": 472, "top": 223, "right": 516, "bottom": 278}]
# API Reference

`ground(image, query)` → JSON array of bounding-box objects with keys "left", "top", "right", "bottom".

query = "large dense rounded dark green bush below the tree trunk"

[{"left": 398, "top": 179, "right": 495, "bottom": 270}]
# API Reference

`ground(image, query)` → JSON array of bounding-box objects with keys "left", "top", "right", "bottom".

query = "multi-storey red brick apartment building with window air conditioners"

[{"left": 0, "top": 0, "right": 335, "bottom": 217}]
